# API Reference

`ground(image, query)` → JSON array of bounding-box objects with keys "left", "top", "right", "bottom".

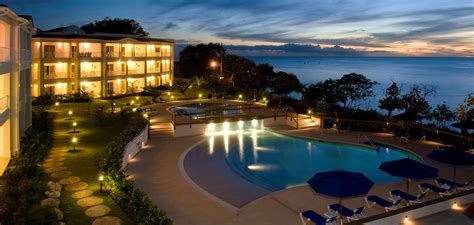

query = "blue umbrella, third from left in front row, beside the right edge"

[{"left": 428, "top": 150, "right": 474, "bottom": 182}]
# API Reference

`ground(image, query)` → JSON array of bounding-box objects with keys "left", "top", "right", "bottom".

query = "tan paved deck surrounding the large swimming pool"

[{"left": 128, "top": 100, "right": 474, "bottom": 225}]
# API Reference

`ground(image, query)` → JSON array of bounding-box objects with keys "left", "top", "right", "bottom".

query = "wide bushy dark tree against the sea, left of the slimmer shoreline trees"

[{"left": 337, "top": 73, "right": 377, "bottom": 107}]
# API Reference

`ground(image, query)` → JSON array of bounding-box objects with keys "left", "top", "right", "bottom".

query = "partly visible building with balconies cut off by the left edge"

[{"left": 0, "top": 4, "right": 35, "bottom": 176}]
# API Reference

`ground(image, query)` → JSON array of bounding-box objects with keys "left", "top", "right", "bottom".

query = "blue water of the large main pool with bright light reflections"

[{"left": 189, "top": 123, "right": 421, "bottom": 191}]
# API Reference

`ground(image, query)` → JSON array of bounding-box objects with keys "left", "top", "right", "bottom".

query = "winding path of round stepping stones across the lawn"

[{"left": 43, "top": 109, "right": 123, "bottom": 225}]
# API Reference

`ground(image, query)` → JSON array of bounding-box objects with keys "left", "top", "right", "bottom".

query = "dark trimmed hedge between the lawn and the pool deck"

[{"left": 100, "top": 109, "right": 172, "bottom": 225}]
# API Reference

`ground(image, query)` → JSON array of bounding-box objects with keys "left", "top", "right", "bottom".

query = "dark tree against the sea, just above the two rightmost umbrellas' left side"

[{"left": 402, "top": 84, "right": 436, "bottom": 115}]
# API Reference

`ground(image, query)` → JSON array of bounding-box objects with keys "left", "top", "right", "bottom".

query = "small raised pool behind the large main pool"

[{"left": 170, "top": 102, "right": 237, "bottom": 118}]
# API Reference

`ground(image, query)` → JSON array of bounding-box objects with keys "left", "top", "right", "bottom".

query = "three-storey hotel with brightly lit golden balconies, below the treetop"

[{"left": 31, "top": 26, "right": 174, "bottom": 97}]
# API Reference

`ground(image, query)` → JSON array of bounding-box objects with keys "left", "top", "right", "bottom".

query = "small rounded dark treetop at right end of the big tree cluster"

[{"left": 271, "top": 71, "right": 303, "bottom": 95}]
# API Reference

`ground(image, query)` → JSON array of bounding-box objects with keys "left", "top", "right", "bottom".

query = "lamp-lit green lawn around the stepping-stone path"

[{"left": 52, "top": 101, "right": 133, "bottom": 225}]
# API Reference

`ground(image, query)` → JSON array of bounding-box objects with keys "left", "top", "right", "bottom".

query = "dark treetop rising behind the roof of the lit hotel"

[{"left": 81, "top": 17, "right": 149, "bottom": 36}]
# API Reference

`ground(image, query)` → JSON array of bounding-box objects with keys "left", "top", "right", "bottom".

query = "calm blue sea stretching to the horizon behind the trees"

[{"left": 248, "top": 56, "right": 474, "bottom": 109}]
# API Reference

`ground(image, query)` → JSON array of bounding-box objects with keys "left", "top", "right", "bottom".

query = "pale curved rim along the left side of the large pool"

[{"left": 178, "top": 138, "right": 241, "bottom": 213}]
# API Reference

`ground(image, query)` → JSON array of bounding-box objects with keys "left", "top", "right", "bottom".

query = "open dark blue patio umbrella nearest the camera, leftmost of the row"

[{"left": 307, "top": 170, "right": 374, "bottom": 223}]
